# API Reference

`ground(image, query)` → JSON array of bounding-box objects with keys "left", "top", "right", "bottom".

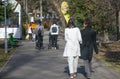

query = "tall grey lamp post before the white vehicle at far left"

[{"left": 2, "top": 0, "right": 8, "bottom": 53}]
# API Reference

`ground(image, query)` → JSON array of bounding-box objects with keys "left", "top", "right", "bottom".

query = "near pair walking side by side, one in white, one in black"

[{"left": 63, "top": 19, "right": 98, "bottom": 79}]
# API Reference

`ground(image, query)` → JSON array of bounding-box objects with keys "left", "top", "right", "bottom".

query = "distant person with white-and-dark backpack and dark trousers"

[{"left": 50, "top": 21, "right": 59, "bottom": 49}]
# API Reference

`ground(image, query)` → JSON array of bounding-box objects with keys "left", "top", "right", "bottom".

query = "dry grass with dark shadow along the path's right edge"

[{"left": 94, "top": 42, "right": 120, "bottom": 72}]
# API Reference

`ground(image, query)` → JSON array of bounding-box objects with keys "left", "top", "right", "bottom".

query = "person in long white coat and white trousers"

[{"left": 63, "top": 19, "right": 82, "bottom": 78}]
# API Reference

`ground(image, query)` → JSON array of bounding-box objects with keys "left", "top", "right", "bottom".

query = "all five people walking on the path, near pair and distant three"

[{"left": 28, "top": 19, "right": 98, "bottom": 79}]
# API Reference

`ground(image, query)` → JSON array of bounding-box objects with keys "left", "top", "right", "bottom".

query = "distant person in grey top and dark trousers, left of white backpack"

[{"left": 35, "top": 21, "right": 44, "bottom": 49}]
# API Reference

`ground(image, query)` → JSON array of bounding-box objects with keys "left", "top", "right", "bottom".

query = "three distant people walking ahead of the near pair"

[{"left": 28, "top": 21, "right": 59, "bottom": 49}]
